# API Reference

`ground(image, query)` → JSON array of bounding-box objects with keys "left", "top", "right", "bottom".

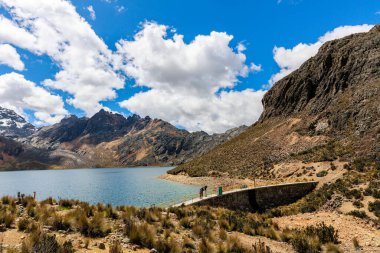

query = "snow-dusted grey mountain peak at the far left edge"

[{"left": 0, "top": 107, "right": 36, "bottom": 138}]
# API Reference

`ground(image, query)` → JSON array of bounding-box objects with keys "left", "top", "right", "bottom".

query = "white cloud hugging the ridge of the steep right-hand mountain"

[{"left": 269, "top": 24, "right": 373, "bottom": 86}]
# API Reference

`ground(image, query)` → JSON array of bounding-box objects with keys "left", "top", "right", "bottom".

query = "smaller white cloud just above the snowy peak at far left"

[{"left": 0, "top": 72, "right": 67, "bottom": 124}]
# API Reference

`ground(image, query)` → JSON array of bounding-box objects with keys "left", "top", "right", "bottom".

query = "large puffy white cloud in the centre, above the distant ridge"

[{"left": 117, "top": 23, "right": 264, "bottom": 133}]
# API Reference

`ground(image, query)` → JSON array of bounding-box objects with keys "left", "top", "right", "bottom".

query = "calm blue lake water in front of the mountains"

[{"left": 0, "top": 167, "right": 197, "bottom": 207}]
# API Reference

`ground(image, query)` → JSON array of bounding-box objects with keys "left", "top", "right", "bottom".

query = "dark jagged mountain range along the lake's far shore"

[{"left": 0, "top": 107, "right": 247, "bottom": 169}]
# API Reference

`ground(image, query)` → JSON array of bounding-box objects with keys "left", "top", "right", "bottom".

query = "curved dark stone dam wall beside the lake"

[{"left": 189, "top": 182, "right": 318, "bottom": 211}]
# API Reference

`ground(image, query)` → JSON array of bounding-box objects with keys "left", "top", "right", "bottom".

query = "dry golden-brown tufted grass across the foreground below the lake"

[{"left": 0, "top": 196, "right": 339, "bottom": 253}]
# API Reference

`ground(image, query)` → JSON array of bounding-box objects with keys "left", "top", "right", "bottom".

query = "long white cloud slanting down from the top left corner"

[{"left": 0, "top": 0, "right": 124, "bottom": 116}]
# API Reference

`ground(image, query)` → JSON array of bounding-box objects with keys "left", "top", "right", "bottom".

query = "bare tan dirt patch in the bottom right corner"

[{"left": 273, "top": 212, "right": 380, "bottom": 252}]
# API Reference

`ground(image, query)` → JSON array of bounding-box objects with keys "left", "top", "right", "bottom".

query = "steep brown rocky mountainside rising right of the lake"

[{"left": 171, "top": 25, "right": 380, "bottom": 177}]
